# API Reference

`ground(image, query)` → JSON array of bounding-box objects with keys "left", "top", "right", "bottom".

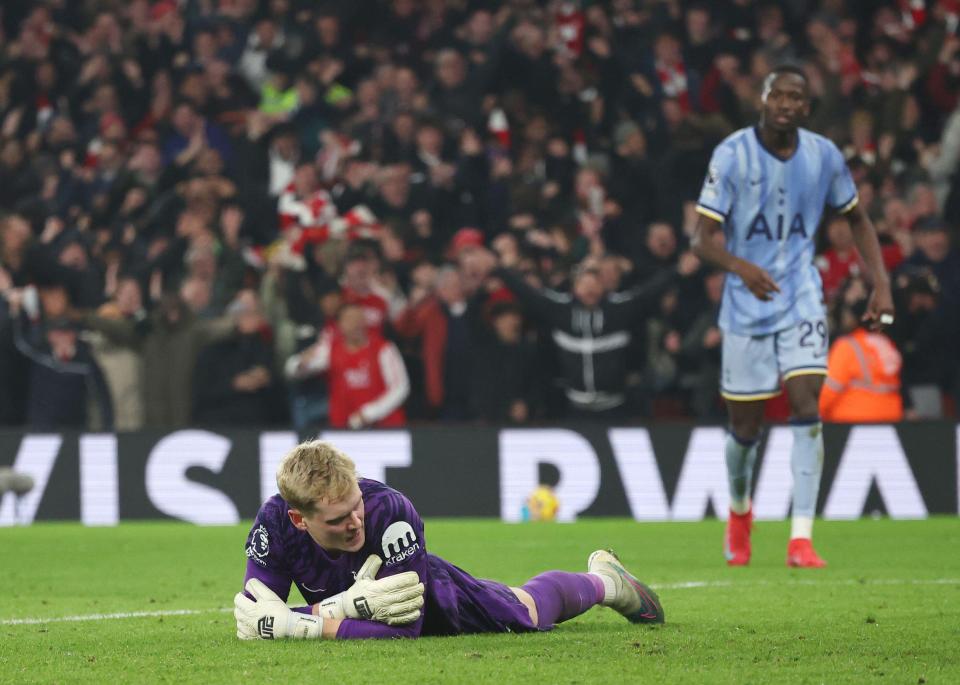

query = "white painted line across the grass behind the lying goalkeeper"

[{"left": 0, "top": 578, "right": 960, "bottom": 626}]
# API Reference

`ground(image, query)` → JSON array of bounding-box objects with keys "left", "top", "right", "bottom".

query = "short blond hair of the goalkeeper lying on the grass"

[{"left": 277, "top": 440, "right": 357, "bottom": 516}]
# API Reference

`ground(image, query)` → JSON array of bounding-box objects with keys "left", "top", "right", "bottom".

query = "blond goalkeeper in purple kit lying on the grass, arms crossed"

[{"left": 234, "top": 441, "right": 663, "bottom": 639}]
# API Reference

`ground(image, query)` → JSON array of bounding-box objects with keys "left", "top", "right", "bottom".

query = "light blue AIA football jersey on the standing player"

[{"left": 697, "top": 127, "right": 857, "bottom": 336}]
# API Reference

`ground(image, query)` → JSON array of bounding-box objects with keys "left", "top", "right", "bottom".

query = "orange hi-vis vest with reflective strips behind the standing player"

[{"left": 820, "top": 328, "right": 903, "bottom": 423}]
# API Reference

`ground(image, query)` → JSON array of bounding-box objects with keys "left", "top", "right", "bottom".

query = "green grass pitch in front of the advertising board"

[{"left": 0, "top": 518, "right": 960, "bottom": 683}]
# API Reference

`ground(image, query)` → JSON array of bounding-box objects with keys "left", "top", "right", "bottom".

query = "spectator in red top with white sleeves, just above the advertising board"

[{"left": 286, "top": 303, "right": 410, "bottom": 428}]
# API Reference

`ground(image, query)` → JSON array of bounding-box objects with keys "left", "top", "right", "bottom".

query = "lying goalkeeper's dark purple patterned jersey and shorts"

[{"left": 244, "top": 478, "right": 537, "bottom": 638}]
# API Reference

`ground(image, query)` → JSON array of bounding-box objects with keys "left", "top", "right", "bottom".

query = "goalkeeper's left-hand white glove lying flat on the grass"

[{"left": 233, "top": 578, "right": 323, "bottom": 640}]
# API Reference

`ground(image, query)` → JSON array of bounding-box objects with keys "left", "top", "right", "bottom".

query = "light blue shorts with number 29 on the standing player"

[{"left": 720, "top": 318, "right": 829, "bottom": 402}]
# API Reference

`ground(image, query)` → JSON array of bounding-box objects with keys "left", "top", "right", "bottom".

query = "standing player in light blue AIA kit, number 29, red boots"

[{"left": 693, "top": 66, "right": 893, "bottom": 568}]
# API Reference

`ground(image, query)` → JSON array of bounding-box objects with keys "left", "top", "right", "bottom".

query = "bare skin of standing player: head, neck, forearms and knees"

[{"left": 693, "top": 71, "right": 893, "bottom": 432}]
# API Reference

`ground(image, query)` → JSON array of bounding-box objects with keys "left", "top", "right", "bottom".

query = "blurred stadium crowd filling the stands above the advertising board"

[{"left": 0, "top": 0, "right": 960, "bottom": 430}]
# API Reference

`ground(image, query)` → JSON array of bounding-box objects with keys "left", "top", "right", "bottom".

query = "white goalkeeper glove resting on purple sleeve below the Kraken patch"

[{"left": 319, "top": 554, "right": 423, "bottom": 626}]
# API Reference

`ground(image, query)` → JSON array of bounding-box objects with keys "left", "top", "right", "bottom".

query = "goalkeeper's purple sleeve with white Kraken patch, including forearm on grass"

[{"left": 337, "top": 491, "right": 430, "bottom": 640}]
